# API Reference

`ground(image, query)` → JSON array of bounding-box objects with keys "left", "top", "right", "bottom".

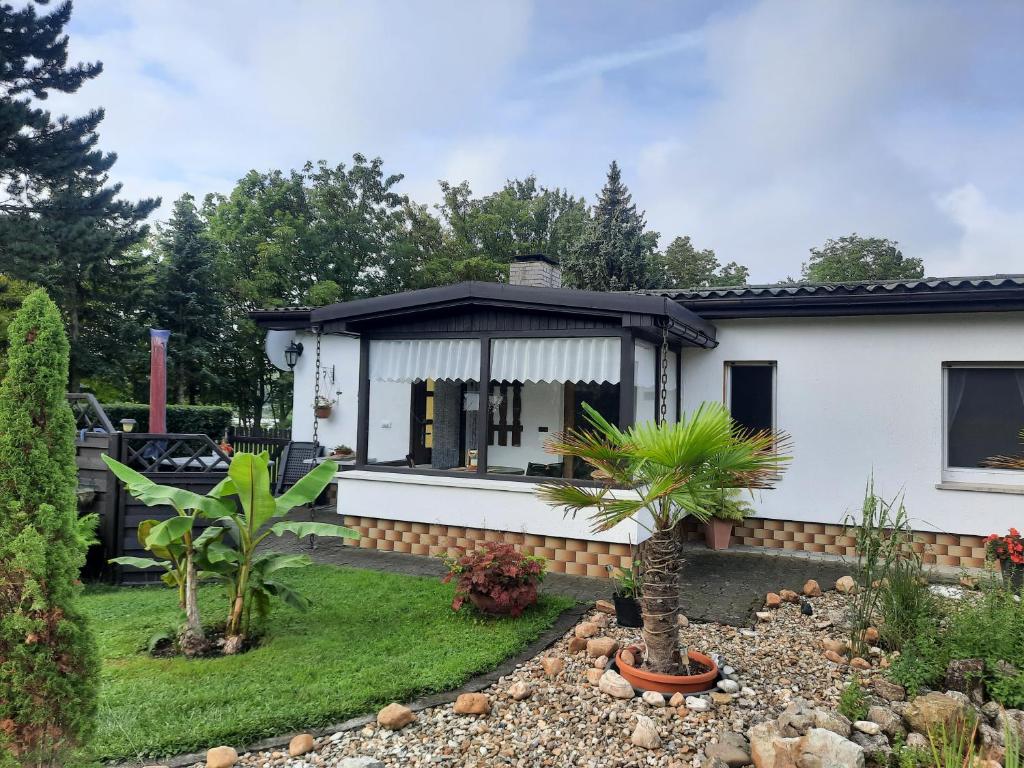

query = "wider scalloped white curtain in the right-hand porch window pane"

[{"left": 490, "top": 337, "right": 620, "bottom": 384}]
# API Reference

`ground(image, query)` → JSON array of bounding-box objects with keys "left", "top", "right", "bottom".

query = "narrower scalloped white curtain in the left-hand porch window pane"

[{"left": 370, "top": 339, "right": 480, "bottom": 382}]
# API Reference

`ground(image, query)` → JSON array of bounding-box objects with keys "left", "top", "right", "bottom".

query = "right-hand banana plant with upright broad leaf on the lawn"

[{"left": 203, "top": 452, "right": 359, "bottom": 653}]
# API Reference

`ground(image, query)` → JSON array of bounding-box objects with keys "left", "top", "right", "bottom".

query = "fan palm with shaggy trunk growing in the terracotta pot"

[{"left": 538, "top": 402, "right": 791, "bottom": 675}]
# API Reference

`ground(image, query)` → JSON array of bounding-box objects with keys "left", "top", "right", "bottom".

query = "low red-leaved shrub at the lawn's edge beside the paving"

[{"left": 440, "top": 542, "right": 545, "bottom": 616}]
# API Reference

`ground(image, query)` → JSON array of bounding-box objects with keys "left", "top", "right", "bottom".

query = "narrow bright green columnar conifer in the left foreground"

[{"left": 0, "top": 289, "right": 98, "bottom": 767}]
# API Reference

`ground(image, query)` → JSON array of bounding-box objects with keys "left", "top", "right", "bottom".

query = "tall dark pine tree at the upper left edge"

[{"left": 0, "top": 2, "right": 160, "bottom": 390}]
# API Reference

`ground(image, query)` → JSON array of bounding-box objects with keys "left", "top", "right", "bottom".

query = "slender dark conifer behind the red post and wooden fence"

[{"left": 154, "top": 194, "right": 224, "bottom": 403}]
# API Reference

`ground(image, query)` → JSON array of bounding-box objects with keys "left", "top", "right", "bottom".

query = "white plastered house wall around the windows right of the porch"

[{"left": 682, "top": 312, "right": 1024, "bottom": 535}]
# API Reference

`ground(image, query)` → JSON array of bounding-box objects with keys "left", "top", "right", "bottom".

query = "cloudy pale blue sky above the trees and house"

[{"left": 58, "top": 0, "right": 1024, "bottom": 283}]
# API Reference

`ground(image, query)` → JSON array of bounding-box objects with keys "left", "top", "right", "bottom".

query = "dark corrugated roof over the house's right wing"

[{"left": 635, "top": 274, "right": 1024, "bottom": 319}]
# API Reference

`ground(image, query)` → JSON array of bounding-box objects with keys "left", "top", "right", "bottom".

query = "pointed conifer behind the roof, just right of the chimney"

[{"left": 562, "top": 161, "right": 657, "bottom": 291}]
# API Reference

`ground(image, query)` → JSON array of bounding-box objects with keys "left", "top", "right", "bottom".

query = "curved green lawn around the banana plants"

[{"left": 82, "top": 565, "right": 571, "bottom": 760}]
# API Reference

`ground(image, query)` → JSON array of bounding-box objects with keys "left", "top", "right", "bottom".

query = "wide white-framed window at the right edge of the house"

[{"left": 944, "top": 364, "right": 1024, "bottom": 483}]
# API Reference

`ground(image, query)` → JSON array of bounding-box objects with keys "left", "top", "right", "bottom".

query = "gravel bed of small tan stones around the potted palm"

[{"left": 224, "top": 592, "right": 849, "bottom": 768}]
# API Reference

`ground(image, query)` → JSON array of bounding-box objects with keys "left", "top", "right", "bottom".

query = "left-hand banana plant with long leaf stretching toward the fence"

[{"left": 102, "top": 455, "right": 232, "bottom": 655}]
